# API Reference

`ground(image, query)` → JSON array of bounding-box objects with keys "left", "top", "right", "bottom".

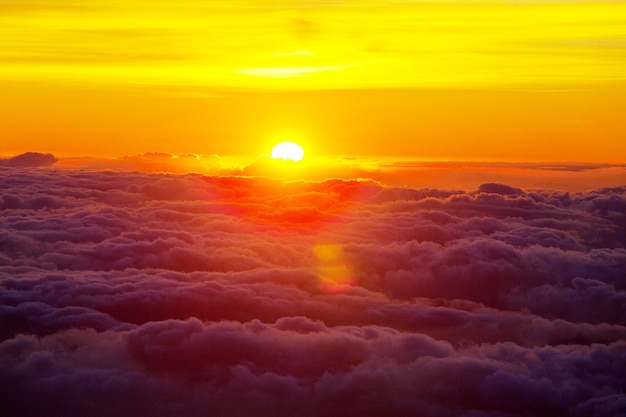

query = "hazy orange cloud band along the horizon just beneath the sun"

[{"left": 56, "top": 152, "right": 626, "bottom": 192}]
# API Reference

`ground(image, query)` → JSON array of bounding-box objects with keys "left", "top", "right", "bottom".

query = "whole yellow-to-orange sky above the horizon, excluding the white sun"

[{"left": 0, "top": 0, "right": 626, "bottom": 163}]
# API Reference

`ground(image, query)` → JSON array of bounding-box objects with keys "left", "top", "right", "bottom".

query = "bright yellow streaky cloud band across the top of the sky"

[{"left": 0, "top": 1, "right": 626, "bottom": 88}]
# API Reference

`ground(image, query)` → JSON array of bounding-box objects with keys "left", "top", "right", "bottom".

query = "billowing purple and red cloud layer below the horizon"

[{"left": 0, "top": 167, "right": 626, "bottom": 417}]
